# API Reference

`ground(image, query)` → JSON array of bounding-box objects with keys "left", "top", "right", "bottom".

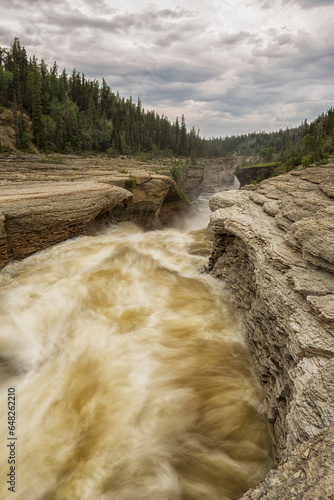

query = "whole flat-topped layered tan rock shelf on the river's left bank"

[{"left": 0, "top": 157, "right": 191, "bottom": 268}]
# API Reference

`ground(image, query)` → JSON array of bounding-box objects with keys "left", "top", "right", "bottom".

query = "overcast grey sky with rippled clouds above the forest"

[{"left": 0, "top": 0, "right": 334, "bottom": 137}]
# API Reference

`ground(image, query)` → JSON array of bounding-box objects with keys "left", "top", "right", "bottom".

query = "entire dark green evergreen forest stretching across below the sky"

[{"left": 0, "top": 38, "right": 334, "bottom": 167}]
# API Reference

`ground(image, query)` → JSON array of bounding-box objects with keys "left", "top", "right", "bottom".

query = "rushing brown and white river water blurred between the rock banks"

[{"left": 0, "top": 200, "right": 270, "bottom": 500}]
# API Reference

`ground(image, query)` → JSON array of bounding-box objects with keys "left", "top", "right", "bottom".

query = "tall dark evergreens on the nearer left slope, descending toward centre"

[{"left": 0, "top": 38, "right": 200, "bottom": 156}]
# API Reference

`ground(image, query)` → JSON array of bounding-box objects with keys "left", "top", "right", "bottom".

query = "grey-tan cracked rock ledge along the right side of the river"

[{"left": 208, "top": 165, "right": 334, "bottom": 498}]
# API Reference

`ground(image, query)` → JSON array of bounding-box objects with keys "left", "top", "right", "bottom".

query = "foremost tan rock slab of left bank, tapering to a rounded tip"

[{"left": 0, "top": 182, "right": 132, "bottom": 265}]
